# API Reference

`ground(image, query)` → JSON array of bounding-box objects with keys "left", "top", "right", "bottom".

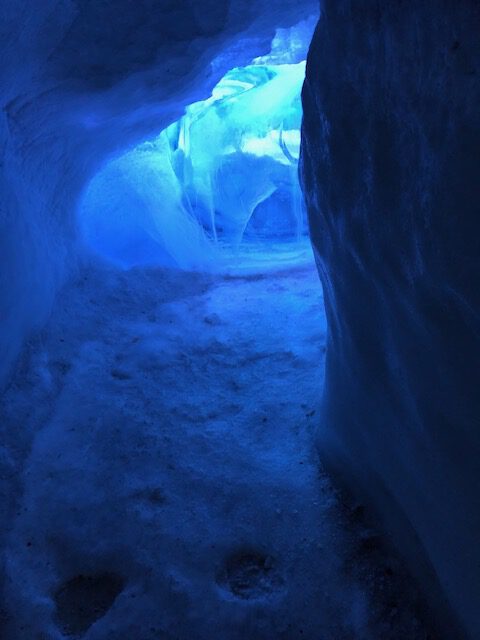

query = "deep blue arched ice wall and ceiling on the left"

[{"left": 0, "top": 0, "right": 318, "bottom": 386}]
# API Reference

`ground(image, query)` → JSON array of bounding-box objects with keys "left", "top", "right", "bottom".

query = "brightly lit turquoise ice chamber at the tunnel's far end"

[{"left": 80, "top": 58, "right": 312, "bottom": 270}]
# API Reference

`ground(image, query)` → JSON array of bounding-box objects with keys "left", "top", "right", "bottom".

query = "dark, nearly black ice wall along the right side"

[{"left": 303, "top": 0, "right": 480, "bottom": 640}]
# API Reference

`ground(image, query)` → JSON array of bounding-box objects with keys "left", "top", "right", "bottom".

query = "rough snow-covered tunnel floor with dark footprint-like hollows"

[{"left": 0, "top": 262, "right": 436, "bottom": 640}]
